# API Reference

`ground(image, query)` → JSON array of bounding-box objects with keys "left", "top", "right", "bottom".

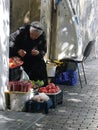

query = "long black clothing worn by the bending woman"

[{"left": 10, "top": 25, "right": 47, "bottom": 84}]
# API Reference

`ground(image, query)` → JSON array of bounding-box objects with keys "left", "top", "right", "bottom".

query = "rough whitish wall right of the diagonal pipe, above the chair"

[{"left": 77, "top": 0, "right": 98, "bottom": 58}]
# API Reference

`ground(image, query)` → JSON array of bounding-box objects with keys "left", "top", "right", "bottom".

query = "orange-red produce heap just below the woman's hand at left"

[{"left": 9, "top": 57, "right": 23, "bottom": 69}]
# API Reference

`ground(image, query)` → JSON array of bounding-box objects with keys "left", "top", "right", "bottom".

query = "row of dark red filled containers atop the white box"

[{"left": 9, "top": 80, "right": 32, "bottom": 92}]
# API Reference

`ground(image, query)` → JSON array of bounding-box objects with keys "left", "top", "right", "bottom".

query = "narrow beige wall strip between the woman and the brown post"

[{"left": 40, "top": 0, "right": 52, "bottom": 60}]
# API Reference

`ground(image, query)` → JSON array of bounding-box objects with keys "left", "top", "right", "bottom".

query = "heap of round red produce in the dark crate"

[{"left": 38, "top": 83, "right": 60, "bottom": 93}]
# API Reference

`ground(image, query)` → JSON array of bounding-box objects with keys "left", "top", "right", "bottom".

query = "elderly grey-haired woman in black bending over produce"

[{"left": 10, "top": 22, "right": 48, "bottom": 85}]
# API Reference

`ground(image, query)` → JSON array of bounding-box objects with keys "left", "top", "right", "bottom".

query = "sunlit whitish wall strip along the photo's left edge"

[{"left": 0, "top": 0, "right": 10, "bottom": 110}]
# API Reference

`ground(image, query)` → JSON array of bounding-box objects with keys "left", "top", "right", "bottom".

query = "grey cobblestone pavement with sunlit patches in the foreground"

[{"left": 0, "top": 59, "right": 98, "bottom": 130}]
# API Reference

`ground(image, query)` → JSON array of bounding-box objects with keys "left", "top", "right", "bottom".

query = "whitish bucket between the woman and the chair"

[{"left": 47, "top": 64, "right": 56, "bottom": 77}]
